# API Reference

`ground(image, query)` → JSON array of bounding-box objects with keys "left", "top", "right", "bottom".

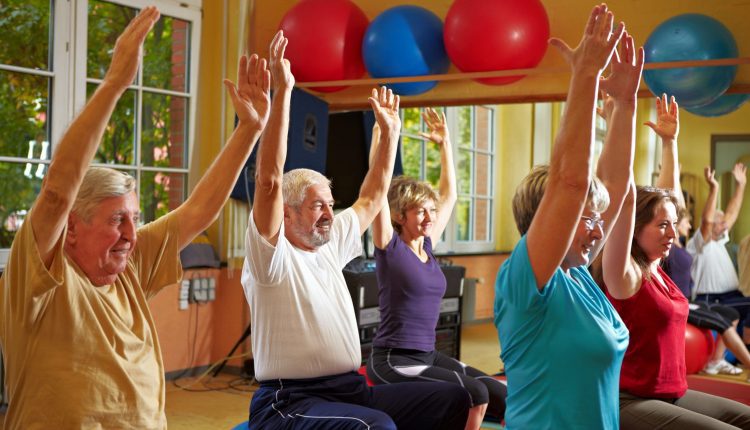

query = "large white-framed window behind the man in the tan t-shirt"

[{"left": 0, "top": 0, "right": 201, "bottom": 267}]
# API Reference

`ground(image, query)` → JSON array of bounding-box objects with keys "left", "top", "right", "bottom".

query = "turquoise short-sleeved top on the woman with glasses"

[{"left": 495, "top": 236, "right": 628, "bottom": 430}]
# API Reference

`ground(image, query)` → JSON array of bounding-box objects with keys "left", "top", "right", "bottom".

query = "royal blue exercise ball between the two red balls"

[{"left": 362, "top": 6, "right": 450, "bottom": 96}]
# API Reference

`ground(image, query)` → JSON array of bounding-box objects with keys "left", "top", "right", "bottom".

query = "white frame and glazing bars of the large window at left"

[{"left": 0, "top": 0, "right": 202, "bottom": 269}]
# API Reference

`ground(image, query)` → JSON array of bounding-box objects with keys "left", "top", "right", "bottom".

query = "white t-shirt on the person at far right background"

[{"left": 685, "top": 230, "right": 740, "bottom": 294}]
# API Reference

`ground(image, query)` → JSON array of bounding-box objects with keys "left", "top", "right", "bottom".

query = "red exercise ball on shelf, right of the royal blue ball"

[{"left": 443, "top": 0, "right": 549, "bottom": 85}]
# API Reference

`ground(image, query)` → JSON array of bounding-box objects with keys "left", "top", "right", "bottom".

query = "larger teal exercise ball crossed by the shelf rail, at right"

[{"left": 643, "top": 13, "right": 737, "bottom": 108}]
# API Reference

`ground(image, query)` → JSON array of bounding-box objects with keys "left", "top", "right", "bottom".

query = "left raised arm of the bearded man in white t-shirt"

[{"left": 253, "top": 31, "right": 294, "bottom": 245}]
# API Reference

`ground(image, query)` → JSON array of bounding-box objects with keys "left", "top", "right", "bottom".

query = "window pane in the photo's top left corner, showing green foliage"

[{"left": 0, "top": 0, "right": 52, "bottom": 70}]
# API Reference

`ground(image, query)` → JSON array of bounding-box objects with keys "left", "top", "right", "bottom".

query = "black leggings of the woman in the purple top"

[{"left": 367, "top": 347, "right": 507, "bottom": 420}]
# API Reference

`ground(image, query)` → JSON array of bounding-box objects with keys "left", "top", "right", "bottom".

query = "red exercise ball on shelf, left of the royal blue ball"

[{"left": 279, "top": 0, "right": 369, "bottom": 92}]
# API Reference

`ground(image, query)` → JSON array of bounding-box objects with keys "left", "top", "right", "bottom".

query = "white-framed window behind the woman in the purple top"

[{"left": 401, "top": 106, "right": 495, "bottom": 253}]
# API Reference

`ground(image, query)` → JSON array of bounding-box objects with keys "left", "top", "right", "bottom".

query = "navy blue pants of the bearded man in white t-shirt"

[{"left": 248, "top": 372, "right": 470, "bottom": 430}]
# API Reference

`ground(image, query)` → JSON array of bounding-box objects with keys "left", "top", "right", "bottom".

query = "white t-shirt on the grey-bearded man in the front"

[{"left": 242, "top": 208, "right": 362, "bottom": 381}]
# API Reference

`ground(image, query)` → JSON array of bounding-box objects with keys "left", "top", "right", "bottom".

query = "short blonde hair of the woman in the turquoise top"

[{"left": 513, "top": 165, "right": 609, "bottom": 235}]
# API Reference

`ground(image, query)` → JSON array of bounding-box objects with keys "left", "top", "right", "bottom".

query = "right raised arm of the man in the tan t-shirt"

[{"left": 169, "top": 54, "right": 271, "bottom": 249}]
